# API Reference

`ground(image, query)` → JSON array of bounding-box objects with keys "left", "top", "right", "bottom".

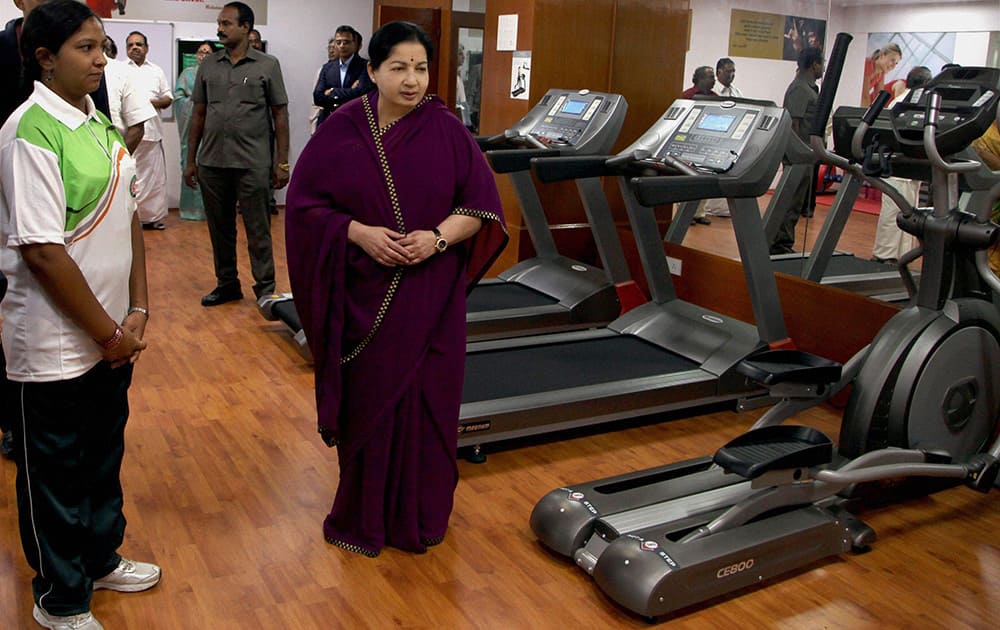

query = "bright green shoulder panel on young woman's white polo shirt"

[{"left": 17, "top": 105, "right": 119, "bottom": 231}]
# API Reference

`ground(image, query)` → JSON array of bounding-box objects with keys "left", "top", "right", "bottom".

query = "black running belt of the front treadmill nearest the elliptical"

[{"left": 462, "top": 335, "right": 699, "bottom": 403}]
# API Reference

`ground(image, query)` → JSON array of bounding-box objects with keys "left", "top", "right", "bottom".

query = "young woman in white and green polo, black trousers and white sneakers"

[{"left": 0, "top": 0, "right": 160, "bottom": 629}]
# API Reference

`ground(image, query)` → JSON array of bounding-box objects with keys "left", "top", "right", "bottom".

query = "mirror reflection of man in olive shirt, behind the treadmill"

[{"left": 770, "top": 48, "right": 823, "bottom": 255}]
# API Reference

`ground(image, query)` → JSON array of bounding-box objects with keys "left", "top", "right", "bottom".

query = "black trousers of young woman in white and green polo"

[{"left": 12, "top": 361, "right": 132, "bottom": 615}]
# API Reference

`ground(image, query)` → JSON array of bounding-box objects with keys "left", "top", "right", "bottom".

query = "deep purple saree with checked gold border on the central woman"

[{"left": 285, "top": 92, "right": 507, "bottom": 556}]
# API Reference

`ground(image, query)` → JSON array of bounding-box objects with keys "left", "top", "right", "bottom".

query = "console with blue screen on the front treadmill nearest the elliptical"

[{"left": 623, "top": 99, "right": 781, "bottom": 174}]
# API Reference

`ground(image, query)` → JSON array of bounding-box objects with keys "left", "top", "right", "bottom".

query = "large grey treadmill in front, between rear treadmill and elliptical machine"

[{"left": 458, "top": 100, "right": 791, "bottom": 454}]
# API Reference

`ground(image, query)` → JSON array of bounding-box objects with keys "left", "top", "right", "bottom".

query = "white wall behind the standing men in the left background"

[{"left": 0, "top": 0, "right": 373, "bottom": 208}]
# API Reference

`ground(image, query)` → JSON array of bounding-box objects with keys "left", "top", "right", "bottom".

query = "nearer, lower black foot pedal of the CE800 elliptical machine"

[{"left": 713, "top": 425, "right": 833, "bottom": 479}]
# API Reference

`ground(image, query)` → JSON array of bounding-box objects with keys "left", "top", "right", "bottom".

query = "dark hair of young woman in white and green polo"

[{"left": 21, "top": 0, "right": 100, "bottom": 86}]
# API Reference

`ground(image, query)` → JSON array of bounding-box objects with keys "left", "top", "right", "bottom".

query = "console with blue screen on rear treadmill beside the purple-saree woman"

[{"left": 511, "top": 89, "right": 628, "bottom": 155}]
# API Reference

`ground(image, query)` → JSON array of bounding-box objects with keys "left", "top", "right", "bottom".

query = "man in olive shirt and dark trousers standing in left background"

[{"left": 184, "top": 2, "right": 290, "bottom": 306}]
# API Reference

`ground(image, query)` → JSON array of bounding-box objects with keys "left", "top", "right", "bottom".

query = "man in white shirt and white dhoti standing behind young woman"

[{"left": 125, "top": 31, "right": 174, "bottom": 230}]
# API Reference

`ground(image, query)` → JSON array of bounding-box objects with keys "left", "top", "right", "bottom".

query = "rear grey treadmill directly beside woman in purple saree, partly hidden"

[{"left": 466, "top": 89, "right": 645, "bottom": 342}]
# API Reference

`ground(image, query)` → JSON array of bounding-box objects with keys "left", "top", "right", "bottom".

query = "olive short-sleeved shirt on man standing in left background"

[{"left": 191, "top": 48, "right": 288, "bottom": 168}]
